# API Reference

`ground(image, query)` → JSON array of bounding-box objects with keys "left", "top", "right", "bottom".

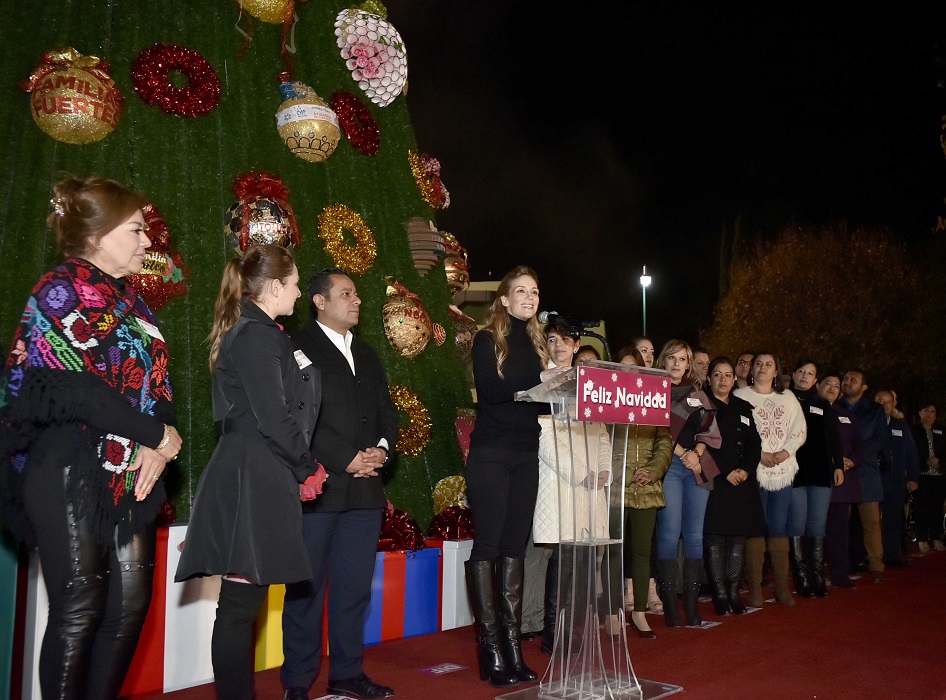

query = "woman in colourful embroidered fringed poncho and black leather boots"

[{"left": 0, "top": 178, "right": 181, "bottom": 699}]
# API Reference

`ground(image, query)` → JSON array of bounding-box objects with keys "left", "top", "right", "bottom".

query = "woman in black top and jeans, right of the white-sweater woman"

[{"left": 788, "top": 359, "right": 844, "bottom": 598}]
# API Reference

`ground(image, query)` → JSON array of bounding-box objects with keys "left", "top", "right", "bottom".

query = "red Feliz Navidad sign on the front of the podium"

[{"left": 576, "top": 366, "right": 670, "bottom": 427}]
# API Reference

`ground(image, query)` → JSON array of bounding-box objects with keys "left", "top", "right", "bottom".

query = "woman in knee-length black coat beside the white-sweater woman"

[{"left": 703, "top": 357, "right": 765, "bottom": 615}]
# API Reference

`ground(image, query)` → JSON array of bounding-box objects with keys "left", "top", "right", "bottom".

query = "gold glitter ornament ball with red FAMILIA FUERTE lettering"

[{"left": 30, "top": 68, "right": 124, "bottom": 144}]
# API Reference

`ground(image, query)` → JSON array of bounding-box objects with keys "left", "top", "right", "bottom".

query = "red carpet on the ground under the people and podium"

[{"left": 139, "top": 551, "right": 946, "bottom": 700}]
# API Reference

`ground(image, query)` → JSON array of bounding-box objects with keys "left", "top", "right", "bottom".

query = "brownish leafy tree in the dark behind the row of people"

[{"left": 702, "top": 225, "right": 946, "bottom": 407}]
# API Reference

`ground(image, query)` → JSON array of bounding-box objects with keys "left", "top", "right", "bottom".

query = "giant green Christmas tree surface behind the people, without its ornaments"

[{"left": 0, "top": 0, "right": 471, "bottom": 527}]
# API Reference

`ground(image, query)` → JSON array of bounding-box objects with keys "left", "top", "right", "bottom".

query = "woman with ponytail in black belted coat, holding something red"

[{"left": 174, "top": 245, "right": 325, "bottom": 700}]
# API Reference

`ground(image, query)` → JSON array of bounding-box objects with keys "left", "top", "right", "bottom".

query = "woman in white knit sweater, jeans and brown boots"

[{"left": 733, "top": 351, "right": 807, "bottom": 607}]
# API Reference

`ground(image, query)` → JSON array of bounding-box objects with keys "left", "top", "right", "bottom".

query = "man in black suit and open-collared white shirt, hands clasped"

[{"left": 280, "top": 268, "right": 398, "bottom": 700}]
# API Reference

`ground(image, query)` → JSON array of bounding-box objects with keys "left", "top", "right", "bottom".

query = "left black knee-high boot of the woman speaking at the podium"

[{"left": 466, "top": 561, "right": 519, "bottom": 688}]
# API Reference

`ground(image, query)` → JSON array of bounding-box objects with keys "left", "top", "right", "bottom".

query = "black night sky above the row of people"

[{"left": 387, "top": 0, "right": 946, "bottom": 350}]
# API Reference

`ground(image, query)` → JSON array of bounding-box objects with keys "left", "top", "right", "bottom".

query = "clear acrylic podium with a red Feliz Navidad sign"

[{"left": 497, "top": 360, "right": 683, "bottom": 700}]
